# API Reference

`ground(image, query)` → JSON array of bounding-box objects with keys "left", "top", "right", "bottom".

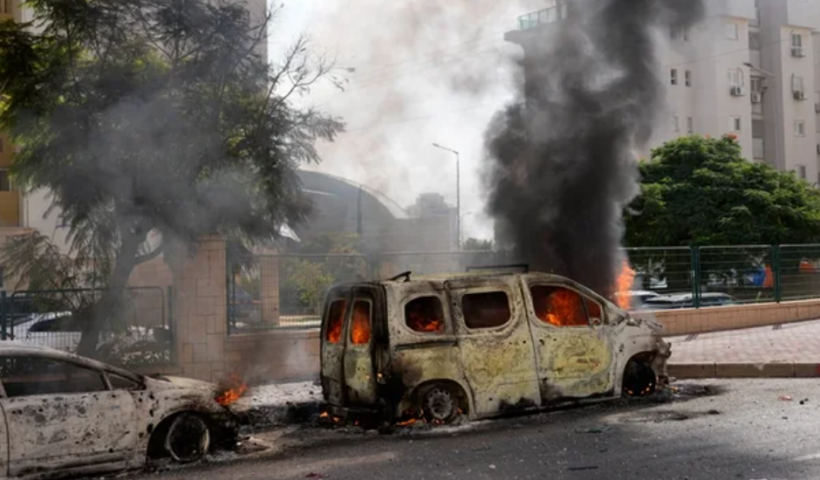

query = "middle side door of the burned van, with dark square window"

[{"left": 446, "top": 277, "right": 541, "bottom": 417}]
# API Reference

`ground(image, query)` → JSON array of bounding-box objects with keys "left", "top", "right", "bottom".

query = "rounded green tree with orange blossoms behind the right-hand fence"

[{"left": 625, "top": 136, "right": 820, "bottom": 247}]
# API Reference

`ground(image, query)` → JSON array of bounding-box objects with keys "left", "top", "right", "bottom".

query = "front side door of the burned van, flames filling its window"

[{"left": 524, "top": 281, "right": 615, "bottom": 405}]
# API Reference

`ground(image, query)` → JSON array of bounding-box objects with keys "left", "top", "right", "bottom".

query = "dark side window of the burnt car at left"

[{"left": 0, "top": 356, "right": 108, "bottom": 398}]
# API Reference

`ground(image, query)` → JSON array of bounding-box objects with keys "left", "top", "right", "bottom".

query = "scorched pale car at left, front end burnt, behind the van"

[{"left": 0, "top": 341, "right": 243, "bottom": 478}]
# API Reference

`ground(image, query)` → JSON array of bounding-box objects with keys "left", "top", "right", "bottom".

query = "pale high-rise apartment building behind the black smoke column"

[{"left": 506, "top": 0, "right": 820, "bottom": 182}]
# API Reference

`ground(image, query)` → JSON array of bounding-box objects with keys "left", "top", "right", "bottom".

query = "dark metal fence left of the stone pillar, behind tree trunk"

[{"left": 0, "top": 287, "right": 175, "bottom": 367}]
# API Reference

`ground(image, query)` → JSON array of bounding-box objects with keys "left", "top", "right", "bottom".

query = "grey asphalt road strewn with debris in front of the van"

[{"left": 115, "top": 380, "right": 820, "bottom": 480}]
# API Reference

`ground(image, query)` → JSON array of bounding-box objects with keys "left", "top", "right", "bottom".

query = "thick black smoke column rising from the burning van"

[{"left": 484, "top": 0, "right": 704, "bottom": 296}]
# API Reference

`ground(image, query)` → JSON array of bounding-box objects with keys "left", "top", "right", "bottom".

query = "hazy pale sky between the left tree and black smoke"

[{"left": 269, "top": 0, "right": 549, "bottom": 239}]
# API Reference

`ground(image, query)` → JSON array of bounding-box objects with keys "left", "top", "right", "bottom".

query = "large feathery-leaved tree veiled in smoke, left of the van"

[{"left": 0, "top": 0, "right": 343, "bottom": 355}]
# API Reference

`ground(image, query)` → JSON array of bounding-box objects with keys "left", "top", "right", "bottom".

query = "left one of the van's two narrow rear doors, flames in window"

[{"left": 321, "top": 288, "right": 352, "bottom": 407}]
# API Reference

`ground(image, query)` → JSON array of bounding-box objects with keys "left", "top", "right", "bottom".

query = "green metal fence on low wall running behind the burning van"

[{"left": 228, "top": 244, "right": 820, "bottom": 333}]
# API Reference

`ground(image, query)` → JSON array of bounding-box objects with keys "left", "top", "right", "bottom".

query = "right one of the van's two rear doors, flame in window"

[{"left": 344, "top": 286, "right": 385, "bottom": 407}]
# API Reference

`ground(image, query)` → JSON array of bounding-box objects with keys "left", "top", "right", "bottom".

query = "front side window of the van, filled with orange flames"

[{"left": 530, "top": 285, "right": 602, "bottom": 327}]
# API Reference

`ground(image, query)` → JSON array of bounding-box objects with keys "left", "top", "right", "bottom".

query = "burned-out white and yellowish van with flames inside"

[{"left": 321, "top": 273, "right": 670, "bottom": 423}]
